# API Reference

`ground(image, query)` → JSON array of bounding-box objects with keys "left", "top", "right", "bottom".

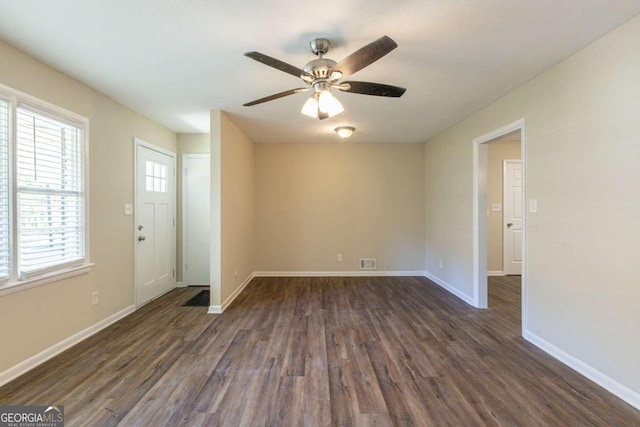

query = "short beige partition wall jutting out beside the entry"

[{"left": 211, "top": 110, "right": 255, "bottom": 306}]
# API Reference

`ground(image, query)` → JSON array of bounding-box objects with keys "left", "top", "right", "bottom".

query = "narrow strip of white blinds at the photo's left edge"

[{"left": 0, "top": 98, "right": 11, "bottom": 280}]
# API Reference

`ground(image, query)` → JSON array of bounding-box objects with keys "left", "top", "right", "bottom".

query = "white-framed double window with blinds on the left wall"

[{"left": 0, "top": 86, "right": 88, "bottom": 290}]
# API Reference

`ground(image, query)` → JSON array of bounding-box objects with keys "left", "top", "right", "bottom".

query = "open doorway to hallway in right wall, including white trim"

[{"left": 473, "top": 120, "right": 526, "bottom": 332}]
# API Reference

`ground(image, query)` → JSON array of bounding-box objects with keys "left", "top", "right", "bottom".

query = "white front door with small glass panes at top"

[{"left": 135, "top": 139, "right": 175, "bottom": 306}]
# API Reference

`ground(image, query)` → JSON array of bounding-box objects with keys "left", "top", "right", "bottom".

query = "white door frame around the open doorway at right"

[{"left": 473, "top": 118, "right": 527, "bottom": 330}]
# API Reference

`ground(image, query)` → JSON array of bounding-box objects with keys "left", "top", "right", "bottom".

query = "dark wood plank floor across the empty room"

[{"left": 0, "top": 277, "right": 640, "bottom": 426}]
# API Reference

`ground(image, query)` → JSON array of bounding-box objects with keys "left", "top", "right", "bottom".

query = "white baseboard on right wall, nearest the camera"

[{"left": 522, "top": 329, "right": 640, "bottom": 409}]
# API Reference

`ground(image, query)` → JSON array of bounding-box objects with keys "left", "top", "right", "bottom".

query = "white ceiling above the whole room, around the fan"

[{"left": 0, "top": 0, "right": 640, "bottom": 142}]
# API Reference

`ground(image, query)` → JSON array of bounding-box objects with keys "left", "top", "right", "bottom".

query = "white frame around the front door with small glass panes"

[{"left": 133, "top": 137, "right": 177, "bottom": 308}]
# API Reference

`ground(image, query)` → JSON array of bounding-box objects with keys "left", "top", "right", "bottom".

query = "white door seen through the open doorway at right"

[{"left": 502, "top": 160, "right": 522, "bottom": 274}]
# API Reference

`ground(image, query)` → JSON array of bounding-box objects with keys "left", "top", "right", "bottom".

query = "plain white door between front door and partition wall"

[{"left": 182, "top": 154, "right": 211, "bottom": 286}]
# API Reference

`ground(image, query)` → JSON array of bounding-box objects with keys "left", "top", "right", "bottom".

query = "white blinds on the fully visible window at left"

[{"left": 15, "top": 105, "right": 85, "bottom": 280}]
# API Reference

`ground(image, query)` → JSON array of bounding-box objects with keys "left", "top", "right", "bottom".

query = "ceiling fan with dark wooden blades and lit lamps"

[{"left": 243, "top": 36, "right": 406, "bottom": 120}]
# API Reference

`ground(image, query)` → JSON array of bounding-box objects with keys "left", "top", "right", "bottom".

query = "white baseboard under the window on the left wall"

[{"left": 0, "top": 305, "right": 136, "bottom": 386}]
